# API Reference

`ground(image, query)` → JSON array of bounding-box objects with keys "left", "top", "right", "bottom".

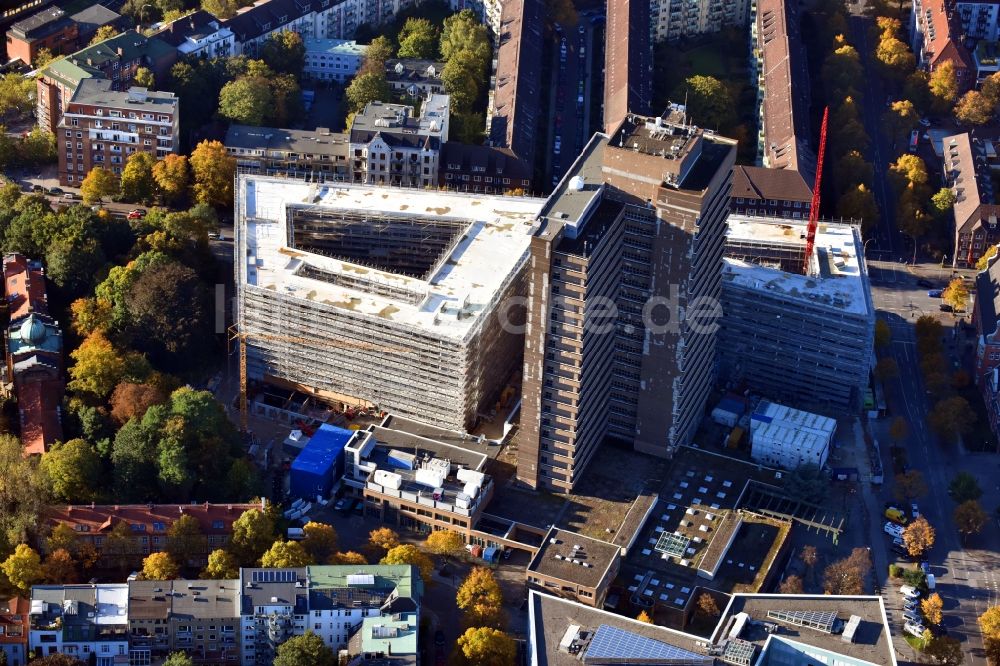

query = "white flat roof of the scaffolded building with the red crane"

[{"left": 722, "top": 214, "right": 872, "bottom": 315}]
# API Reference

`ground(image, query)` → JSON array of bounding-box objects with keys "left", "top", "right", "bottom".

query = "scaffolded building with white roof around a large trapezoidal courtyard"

[{"left": 235, "top": 176, "right": 543, "bottom": 430}]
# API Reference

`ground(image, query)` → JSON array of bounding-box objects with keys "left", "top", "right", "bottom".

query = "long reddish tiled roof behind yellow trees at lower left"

[{"left": 44, "top": 502, "right": 261, "bottom": 535}]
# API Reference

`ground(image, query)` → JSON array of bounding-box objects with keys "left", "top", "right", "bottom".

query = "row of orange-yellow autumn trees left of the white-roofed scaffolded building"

[{"left": 80, "top": 141, "right": 236, "bottom": 207}]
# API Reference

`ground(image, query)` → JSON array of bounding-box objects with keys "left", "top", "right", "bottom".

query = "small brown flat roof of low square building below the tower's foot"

[{"left": 528, "top": 527, "right": 621, "bottom": 587}]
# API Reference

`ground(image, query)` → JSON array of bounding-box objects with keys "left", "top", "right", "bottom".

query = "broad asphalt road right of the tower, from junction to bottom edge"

[{"left": 869, "top": 262, "right": 1000, "bottom": 666}]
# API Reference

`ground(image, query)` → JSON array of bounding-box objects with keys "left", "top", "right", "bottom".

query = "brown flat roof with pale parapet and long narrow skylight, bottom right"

[{"left": 712, "top": 594, "right": 896, "bottom": 666}]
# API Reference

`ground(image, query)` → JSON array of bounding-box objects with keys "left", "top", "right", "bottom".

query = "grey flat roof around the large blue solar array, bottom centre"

[{"left": 528, "top": 590, "right": 714, "bottom": 666}]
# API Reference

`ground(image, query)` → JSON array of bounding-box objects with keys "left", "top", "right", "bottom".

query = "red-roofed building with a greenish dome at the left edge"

[{"left": 3, "top": 254, "right": 64, "bottom": 455}]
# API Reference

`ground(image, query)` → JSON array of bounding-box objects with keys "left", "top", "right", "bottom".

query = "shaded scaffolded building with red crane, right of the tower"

[{"left": 718, "top": 215, "right": 875, "bottom": 408}]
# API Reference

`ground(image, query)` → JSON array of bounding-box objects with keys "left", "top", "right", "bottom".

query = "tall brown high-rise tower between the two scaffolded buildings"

[{"left": 517, "top": 105, "right": 735, "bottom": 492}]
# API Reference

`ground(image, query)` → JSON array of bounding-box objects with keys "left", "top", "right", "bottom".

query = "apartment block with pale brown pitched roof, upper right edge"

[{"left": 942, "top": 132, "right": 1000, "bottom": 268}]
